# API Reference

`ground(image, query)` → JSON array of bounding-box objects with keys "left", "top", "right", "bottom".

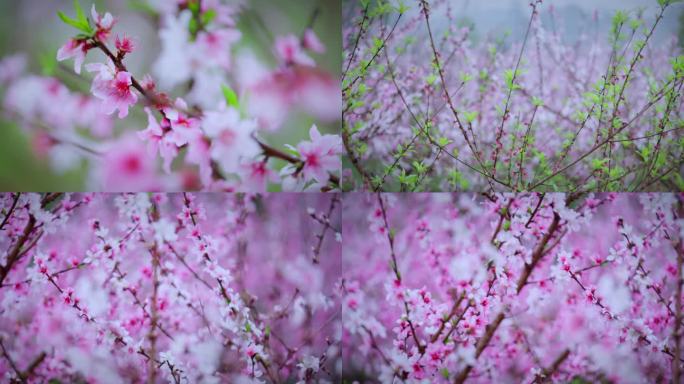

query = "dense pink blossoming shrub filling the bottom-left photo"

[{"left": 0, "top": 193, "right": 341, "bottom": 383}]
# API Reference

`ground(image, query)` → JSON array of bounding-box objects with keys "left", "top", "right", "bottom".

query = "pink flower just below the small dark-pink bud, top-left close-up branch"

[{"left": 86, "top": 61, "right": 138, "bottom": 119}]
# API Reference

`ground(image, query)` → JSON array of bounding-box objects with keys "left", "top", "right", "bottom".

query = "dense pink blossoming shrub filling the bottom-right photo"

[{"left": 341, "top": 193, "right": 684, "bottom": 383}]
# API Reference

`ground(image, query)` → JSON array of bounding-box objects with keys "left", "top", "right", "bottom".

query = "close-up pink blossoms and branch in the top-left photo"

[{"left": 0, "top": 0, "right": 343, "bottom": 192}]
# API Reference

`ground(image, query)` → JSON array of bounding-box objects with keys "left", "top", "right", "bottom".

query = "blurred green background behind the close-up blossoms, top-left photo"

[{"left": 0, "top": 0, "right": 342, "bottom": 191}]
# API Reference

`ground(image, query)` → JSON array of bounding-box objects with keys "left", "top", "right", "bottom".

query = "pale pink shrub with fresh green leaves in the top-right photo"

[{"left": 342, "top": 0, "right": 684, "bottom": 192}]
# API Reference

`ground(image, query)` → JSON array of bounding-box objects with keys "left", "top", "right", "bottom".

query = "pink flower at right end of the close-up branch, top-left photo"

[{"left": 297, "top": 124, "right": 343, "bottom": 182}]
